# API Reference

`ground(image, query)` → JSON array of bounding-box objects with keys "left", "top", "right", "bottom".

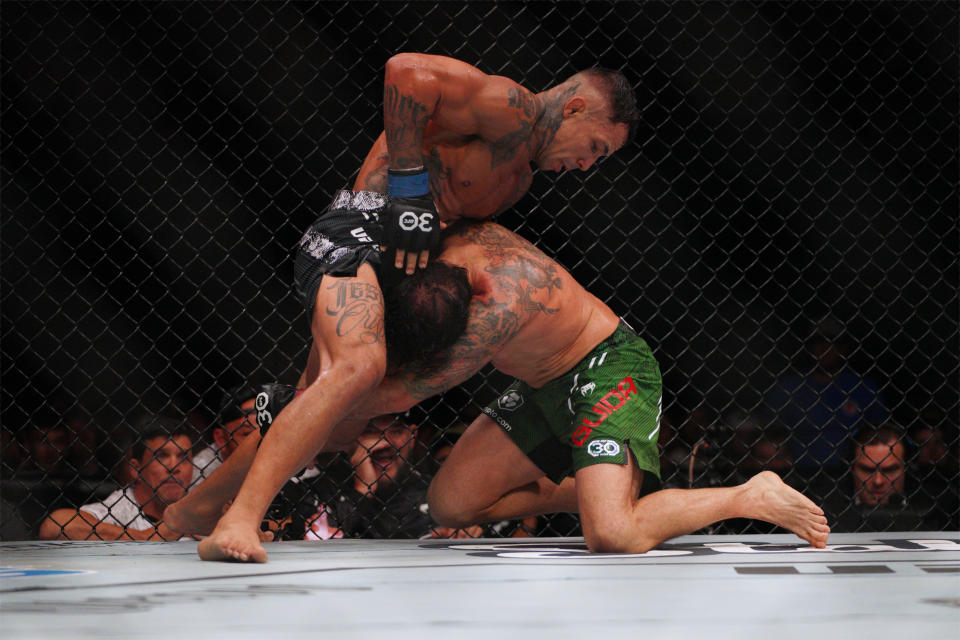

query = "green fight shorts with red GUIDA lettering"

[{"left": 483, "top": 323, "right": 663, "bottom": 494}]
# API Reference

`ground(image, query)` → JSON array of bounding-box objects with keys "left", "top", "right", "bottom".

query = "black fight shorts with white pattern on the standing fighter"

[{"left": 293, "top": 191, "right": 386, "bottom": 317}]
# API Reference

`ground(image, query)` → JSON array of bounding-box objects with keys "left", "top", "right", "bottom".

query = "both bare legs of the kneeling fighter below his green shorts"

[{"left": 428, "top": 415, "right": 830, "bottom": 553}]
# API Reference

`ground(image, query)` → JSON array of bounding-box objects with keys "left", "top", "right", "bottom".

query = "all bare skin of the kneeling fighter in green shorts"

[{"left": 169, "top": 223, "right": 830, "bottom": 557}]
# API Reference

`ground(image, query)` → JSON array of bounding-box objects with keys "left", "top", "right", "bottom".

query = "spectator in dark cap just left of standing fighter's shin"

[{"left": 190, "top": 384, "right": 260, "bottom": 489}]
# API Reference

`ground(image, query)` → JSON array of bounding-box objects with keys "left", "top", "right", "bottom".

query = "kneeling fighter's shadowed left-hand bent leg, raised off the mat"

[{"left": 427, "top": 415, "right": 576, "bottom": 528}]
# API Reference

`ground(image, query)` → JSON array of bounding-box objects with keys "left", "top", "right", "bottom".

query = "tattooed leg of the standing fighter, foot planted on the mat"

[{"left": 198, "top": 264, "right": 386, "bottom": 562}]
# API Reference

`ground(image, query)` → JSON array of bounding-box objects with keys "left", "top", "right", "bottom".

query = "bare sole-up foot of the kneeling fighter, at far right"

[{"left": 743, "top": 471, "right": 830, "bottom": 549}]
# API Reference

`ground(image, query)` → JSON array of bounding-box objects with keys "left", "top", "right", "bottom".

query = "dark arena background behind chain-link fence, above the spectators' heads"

[{"left": 0, "top": 2, "right": 960, "bottom": 524}]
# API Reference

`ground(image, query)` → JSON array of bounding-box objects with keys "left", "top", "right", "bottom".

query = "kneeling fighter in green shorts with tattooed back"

[{"left": 179, "top": 223, "right": 830, "bottom": 558}]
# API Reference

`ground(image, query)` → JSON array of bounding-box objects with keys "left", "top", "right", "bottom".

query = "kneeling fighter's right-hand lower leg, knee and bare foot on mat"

[{"left": 576, "top": 458, "right": 830, "bottom": 553}]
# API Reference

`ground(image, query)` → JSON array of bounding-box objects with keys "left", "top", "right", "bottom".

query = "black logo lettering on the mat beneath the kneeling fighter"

[{"left": 446, "top": 539, "right": 960, "bottom": 560}]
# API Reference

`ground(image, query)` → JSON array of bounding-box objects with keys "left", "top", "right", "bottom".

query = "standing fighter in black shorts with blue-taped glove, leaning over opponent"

[{"left": 200, "top": 54, "right": 637, "bottom": 562}]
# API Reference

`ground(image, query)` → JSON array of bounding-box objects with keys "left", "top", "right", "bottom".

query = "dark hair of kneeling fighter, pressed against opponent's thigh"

[{"left": 384, "top": 260, "right": 473, "bottom": 371}]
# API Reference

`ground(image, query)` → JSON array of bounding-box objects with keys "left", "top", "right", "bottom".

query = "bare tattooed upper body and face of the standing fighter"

[{"left": 354, "top": 54, "right": 627, "bottom": 223}]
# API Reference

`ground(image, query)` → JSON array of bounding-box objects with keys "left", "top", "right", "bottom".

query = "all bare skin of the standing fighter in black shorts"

[{"left": 188, "top": 53, "right": 629, "bottom": 562}]
